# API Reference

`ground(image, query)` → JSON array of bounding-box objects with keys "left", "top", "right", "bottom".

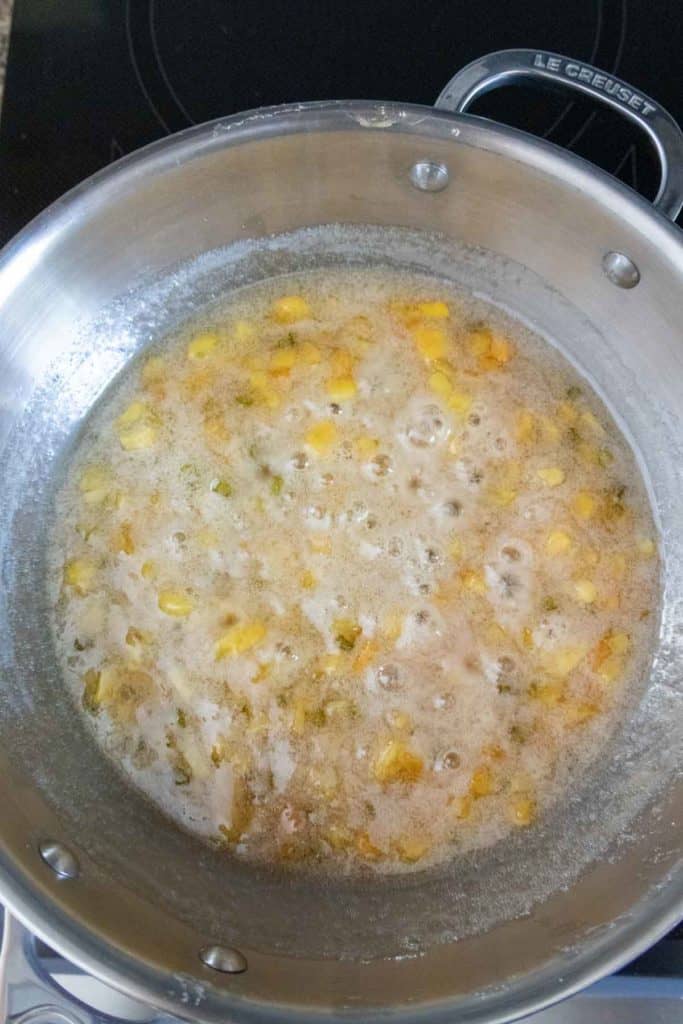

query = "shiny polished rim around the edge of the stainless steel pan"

[{"left": 0, "top": 100, "right": 683, "bottom": 1024}]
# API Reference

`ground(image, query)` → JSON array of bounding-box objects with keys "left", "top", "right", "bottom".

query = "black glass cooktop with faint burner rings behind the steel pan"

[{"left": 0, "top": 0, "right": 683, "bottom": 975}]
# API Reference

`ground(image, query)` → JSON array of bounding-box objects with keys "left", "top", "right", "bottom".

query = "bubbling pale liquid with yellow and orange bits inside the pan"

[{"left": 50, "top": 270, "right": 657, "bottom": 872}]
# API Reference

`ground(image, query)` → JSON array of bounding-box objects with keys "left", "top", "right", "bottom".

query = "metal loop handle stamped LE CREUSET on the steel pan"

[{"left": 434, "top": 50, "right": 683, "bottom": 220}]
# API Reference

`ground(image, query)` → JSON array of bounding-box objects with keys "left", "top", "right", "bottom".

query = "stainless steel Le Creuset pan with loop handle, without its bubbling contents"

[{"left": 0, "top": 50, "right": 683, "bottom": 1024}]
